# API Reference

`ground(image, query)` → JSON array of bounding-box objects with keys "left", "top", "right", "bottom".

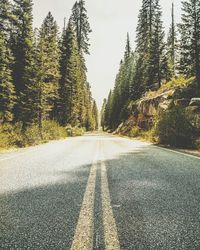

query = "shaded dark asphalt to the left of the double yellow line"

[{"left": 0, "top": 165, "right": 91, "bottom": 249}]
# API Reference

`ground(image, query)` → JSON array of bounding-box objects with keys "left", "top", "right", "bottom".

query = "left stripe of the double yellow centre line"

[{"left": 71, "top": 151, "right": 97, "bottom": 250}]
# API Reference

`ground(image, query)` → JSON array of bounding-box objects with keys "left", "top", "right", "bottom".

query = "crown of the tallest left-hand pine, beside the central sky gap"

[{"left": 71, "top": 0, "right": 91, "bottom": 54}]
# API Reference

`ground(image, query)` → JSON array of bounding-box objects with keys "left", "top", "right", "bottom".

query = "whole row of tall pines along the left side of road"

[{"left": 0, "top": 0, "right": 98, "bottom": 146}]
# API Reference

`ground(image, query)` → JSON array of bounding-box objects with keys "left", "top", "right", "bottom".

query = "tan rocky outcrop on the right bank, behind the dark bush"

[{"left": 117, "top": 81, "right": 200, "bottom": 134}]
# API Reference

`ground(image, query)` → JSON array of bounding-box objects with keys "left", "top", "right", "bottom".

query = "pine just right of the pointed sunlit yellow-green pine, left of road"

[{"left": 59, "top": 20, "right": 81, "bottom": 126}]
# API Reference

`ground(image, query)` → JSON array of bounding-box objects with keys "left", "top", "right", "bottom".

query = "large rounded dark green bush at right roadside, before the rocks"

[{"left": 155, "top": 106, "right": 193, "bottom": 147}]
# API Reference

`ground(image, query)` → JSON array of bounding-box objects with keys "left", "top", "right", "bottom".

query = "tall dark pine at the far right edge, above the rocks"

[{"left": 179, "top": 0, "right": 200, "bottom": 89}]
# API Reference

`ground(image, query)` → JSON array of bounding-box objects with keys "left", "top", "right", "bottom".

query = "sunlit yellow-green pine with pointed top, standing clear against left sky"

[{"left": 37, "top": 12, "right": 60, "bottom": 127}]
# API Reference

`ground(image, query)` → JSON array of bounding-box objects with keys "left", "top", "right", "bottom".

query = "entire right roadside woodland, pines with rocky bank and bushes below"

[{"left": 101, "top": 0, "right": 200, "bottom": 147}]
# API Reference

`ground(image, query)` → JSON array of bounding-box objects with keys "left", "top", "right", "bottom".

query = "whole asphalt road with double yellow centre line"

[{"left": 0, "top": 134, "right": 200, "bottom": 250}]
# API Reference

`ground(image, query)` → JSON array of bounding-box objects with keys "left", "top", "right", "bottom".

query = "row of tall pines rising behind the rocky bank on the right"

[{"left": 101, "top": 0, "right": 200, "bottom": 130}]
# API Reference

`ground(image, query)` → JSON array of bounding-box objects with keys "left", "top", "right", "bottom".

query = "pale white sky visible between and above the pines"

[{"left": 33, "top": 0, "right": 181, "bottom": 108}]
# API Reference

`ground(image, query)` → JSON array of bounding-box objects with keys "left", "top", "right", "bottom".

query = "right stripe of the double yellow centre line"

[{"left": 101, "top": 161, "right": 120, "bottom": 250}]
